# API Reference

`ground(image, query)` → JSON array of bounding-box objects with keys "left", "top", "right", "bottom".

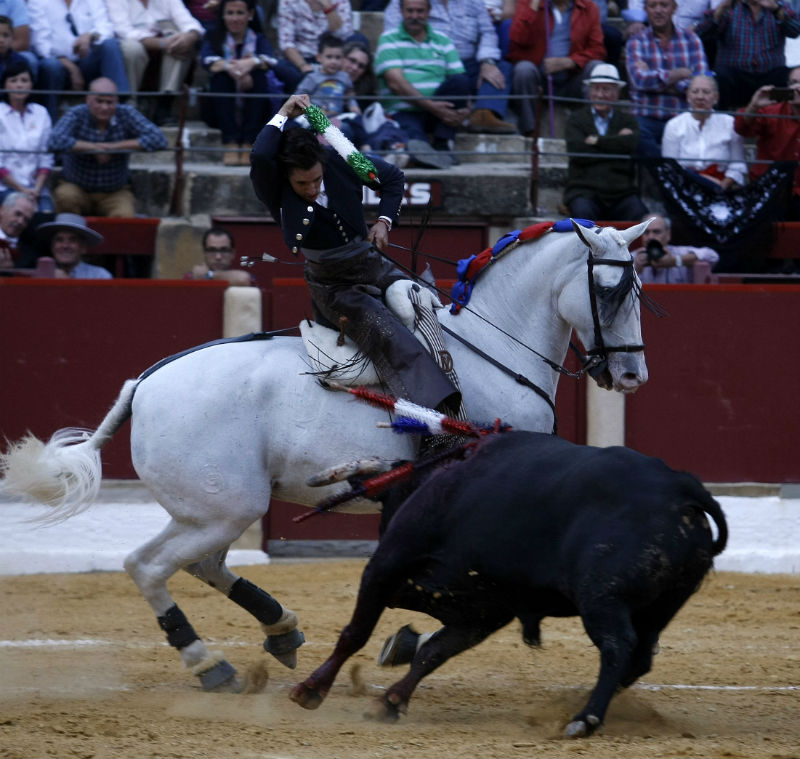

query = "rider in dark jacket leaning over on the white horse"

[{"left": 250, "top": 95, "right": 461, "bottom": 410}]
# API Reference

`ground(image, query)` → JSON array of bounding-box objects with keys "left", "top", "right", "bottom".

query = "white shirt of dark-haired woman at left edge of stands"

[{"left": 0, "top": 102, "right": 53, "bottom": 187}]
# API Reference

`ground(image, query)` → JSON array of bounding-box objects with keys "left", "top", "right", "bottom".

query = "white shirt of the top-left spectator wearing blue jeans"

[{"left": 28, "top": 0, "right": 114, "bottom": 61}]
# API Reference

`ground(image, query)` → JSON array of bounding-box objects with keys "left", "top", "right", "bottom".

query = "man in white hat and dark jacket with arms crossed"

[{"left": 564, "top": 63, "right": 647, "bottom": 221}]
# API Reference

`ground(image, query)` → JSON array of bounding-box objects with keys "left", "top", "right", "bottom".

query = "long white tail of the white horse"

[{"left": 0, "top": 379, "right": 140, "bottom": 522}]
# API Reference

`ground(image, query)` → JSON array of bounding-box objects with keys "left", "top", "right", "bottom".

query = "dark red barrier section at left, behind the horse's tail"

[{"left": 0, "top": 278, "right": 226, "bottom": 478}]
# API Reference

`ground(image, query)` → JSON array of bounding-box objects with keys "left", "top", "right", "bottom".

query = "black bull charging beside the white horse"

[{"left": 291, "top": 432, "right": 728, "bottom": 736}]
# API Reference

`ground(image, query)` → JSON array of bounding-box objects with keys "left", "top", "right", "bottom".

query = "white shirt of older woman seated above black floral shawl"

[{"left": 661, "top": 111, "right": 747, "bottom": 184}]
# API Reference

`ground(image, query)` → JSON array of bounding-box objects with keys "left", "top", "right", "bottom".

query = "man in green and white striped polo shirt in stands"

[{"left": 375, "top": 0, "right": 471, "bottom": 169}]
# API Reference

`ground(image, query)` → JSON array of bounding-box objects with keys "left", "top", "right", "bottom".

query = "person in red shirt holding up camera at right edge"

[{"left": 733, "top": 67, "right": 800, "bottom": 221}]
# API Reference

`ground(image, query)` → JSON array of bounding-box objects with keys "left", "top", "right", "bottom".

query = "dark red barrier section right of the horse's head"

[{"left": 626, "top": 284, "right": 800, "bottom": 482}]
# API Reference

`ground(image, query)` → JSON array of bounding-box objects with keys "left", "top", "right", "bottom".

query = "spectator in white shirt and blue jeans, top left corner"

[{"left": 28, "top": 0, "right": 130, "bottom": 121}]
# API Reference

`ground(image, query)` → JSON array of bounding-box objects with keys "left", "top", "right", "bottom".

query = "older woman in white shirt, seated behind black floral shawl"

[{"left": 661, "top": 75, "right": 747, "bottom": 190}]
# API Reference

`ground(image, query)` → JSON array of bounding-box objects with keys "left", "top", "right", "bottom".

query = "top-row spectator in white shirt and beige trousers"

[{"left": 106, "top": 0, "right": 204, "bottom": 126}]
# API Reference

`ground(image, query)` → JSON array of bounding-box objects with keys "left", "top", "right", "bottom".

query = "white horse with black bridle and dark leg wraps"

[{"left": 0, "top": 222, "right": 647, "bottom": 689}]
